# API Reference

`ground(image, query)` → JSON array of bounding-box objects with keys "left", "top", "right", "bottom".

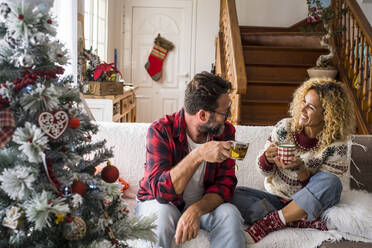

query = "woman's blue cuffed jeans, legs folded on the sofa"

[{"left": 232, "top": 172, "right": 342, "bottom": 225}]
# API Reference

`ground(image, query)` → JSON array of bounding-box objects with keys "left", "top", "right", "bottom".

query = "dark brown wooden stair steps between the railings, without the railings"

[{"left": 240, "top": 28, "right": 327, "bottom": 126}]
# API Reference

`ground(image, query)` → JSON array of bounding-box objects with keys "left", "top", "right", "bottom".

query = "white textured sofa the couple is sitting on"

[{"left": 93, "top": 122, "right": 372, "bottom": 248}]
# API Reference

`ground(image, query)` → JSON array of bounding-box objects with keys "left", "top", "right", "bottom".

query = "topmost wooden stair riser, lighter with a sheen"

[{"left": 241, "top": 33, "right": 322, "bottom": 49}]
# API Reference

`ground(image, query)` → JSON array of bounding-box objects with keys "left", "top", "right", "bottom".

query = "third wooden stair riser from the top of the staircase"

[{"left": 245, "top": 65, "right": 310, "bottom": 82}]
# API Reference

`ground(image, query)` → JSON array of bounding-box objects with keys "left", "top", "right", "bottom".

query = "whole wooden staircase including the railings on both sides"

[{"left": 216, "top": 0, "right": 372, "bottom": 134}]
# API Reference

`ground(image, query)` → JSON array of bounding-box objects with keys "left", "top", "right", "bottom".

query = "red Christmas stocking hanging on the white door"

[{"left": 145, "top": 35, "right": 174, "bottom": 81}]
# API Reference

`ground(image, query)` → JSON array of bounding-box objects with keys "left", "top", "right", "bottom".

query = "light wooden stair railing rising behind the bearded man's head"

[{"left": 216, "top": 0, "right": 247, "bottom": 124}]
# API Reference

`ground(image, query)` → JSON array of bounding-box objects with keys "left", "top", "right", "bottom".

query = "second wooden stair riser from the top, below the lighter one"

[{"left": 243, "top": 45, "right": 328, "bottom": 67}]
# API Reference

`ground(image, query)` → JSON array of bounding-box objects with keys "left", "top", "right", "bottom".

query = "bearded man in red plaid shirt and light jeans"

[{"left": 136, "top": 72, "right": 245, "bottom": 248}]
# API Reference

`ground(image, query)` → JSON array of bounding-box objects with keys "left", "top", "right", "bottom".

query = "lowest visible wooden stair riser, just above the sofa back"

[{"left": 241, "top": 99, "right": 290, "bottom": 124}]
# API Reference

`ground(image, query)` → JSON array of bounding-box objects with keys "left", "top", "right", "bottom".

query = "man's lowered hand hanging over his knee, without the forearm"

[{"left": 175, "top": 206, "right": 201, "bottom": 245}]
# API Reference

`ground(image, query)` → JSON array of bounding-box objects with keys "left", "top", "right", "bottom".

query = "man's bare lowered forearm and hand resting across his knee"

[{"left": 175, "top": 193, "right": 223, "bottom": 244}]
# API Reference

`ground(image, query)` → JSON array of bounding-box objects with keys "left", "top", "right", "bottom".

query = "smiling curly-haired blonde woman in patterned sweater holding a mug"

[{"left": 233, "top": 78, "right": 355, "bottom": 243}]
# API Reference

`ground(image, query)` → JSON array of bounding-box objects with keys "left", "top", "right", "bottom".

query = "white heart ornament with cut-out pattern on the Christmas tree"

[{"left": 37, "top": 110, "right": 69, "bottom": 139}]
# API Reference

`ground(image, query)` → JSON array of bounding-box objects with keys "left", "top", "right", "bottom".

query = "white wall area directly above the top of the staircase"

[{"left": 236, "top": 0, "right": 307, "bottom": 27}]
